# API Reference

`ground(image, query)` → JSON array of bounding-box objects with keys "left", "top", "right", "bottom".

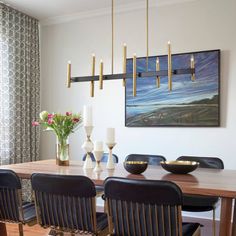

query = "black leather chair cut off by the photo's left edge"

[{"left": 0, "top": 170, "right": 36, "bottom": 236}]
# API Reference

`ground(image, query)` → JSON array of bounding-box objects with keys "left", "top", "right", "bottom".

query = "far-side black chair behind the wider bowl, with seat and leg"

[{"left": 177, "top": 156, "right": 224, "bottom": 236}]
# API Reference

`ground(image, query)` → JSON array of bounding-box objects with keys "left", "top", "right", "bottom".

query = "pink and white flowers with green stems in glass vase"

[{"left": 32, "top": 111, "right": 82, "bottom": 165}]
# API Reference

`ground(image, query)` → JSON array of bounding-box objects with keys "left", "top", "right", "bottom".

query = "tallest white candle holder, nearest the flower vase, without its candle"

[{"left": 82, "top": 126, "right": 93, "bottom": 169}]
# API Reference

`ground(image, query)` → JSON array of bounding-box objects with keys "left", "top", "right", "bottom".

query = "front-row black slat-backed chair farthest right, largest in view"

[{"left": 105, "top": 177, "right": 200, "bottom": 236}]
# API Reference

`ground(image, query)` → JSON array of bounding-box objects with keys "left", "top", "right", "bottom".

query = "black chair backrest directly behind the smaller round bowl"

[{"left": 125, "top": 154, "right": 166, "bottom": 165}]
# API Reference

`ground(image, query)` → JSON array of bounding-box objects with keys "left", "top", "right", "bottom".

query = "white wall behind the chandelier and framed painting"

[{"left": 41, "top": 0, "right": 236, "bottom": 218}]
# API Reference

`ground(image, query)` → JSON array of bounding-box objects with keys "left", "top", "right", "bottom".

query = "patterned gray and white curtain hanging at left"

[{"left": 0, "top": 3, "right": 40, "bottom": 165}]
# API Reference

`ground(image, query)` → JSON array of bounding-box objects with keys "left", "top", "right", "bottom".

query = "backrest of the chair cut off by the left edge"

[{"left": 0, "top": 170, "right": 24, "bottom": 223}]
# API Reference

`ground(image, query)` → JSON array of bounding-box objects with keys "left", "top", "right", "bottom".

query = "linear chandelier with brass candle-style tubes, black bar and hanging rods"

[{"left": 67, "top": 0, "right": 195, "bottom": 97}]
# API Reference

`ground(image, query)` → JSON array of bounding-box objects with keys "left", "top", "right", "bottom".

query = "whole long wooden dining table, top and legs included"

[{"left": 0, "top": 159, "right": 236, "bottom": 236}]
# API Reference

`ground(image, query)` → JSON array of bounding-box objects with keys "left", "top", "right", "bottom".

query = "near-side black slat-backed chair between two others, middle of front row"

[{"left": 31, "top": 174, "right": 108, "bottom": 235}]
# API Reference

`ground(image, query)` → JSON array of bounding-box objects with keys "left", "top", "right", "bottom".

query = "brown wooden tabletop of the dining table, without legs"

[{"left": 0, "top": 160, "right": 236, "bottom": 198}]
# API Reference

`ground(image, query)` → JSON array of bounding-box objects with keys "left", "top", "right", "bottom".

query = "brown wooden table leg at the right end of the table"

[{"left": 220, "top": 198, "right": 233, "bottom": 236}]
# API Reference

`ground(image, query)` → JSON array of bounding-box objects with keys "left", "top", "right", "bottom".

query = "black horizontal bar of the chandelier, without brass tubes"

[{"left": 71, "top": 68, "right": 195, "bottom": 83}]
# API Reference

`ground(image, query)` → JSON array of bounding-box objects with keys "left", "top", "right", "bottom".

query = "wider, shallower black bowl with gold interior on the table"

[{"left": 160, "top": 161, "right": 199, "bottom": 174}]
